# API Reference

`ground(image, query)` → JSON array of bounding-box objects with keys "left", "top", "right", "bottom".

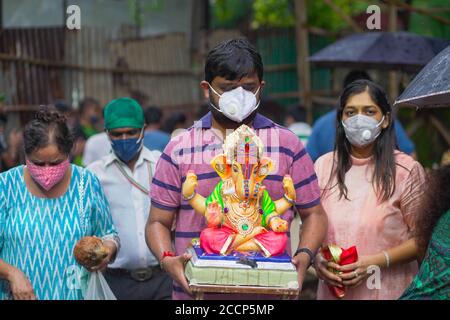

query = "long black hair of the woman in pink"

[{"left": 325, "top": 80, "right": 396, "bottom": 201}]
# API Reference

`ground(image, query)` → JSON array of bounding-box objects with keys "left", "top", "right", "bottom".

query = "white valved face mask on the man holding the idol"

[{"left": 208, "top": 83, "right": 260, "bottom": 123}]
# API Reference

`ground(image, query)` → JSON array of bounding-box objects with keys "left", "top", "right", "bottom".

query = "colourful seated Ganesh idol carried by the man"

[{"left": 182, "top": 125, "right": 296, "bottom": 257}]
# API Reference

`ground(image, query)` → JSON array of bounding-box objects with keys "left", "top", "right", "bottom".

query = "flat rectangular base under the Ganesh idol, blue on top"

[{"left": 185, "top": 246, "right": 298, "bottom": 293}]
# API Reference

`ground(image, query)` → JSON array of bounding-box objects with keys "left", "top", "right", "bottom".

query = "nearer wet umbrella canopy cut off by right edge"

[{"left": 394, "top": 46, "right": 450, "bottom": 107}]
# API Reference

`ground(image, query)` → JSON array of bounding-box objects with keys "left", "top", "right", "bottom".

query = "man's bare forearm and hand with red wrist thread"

[{"left": 145, "top": 206, "right": 192, "bottom": 294}]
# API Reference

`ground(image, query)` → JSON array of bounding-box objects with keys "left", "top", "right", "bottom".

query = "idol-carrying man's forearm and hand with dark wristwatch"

[{"left": 292, "top": 204, "right": 328, "bottom": 292}]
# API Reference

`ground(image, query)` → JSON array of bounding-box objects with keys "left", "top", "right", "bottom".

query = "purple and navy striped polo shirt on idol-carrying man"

[{"left": 151, "top": 113, "right": 320, "bottom": 299}]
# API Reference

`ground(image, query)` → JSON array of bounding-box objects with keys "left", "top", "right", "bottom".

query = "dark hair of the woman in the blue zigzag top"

[{"left": 23, "top": 106, "right": 74, "bottom": 155}]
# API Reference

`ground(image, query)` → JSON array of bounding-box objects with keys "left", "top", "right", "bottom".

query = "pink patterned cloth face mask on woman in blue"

[{"left": 26, "top": 159, "right": 70, "bottom": 191}]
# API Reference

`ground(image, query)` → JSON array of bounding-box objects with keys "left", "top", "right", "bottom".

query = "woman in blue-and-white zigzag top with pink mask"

[{"left": 0, "top": 108, "right": 119, "bottom": 300}]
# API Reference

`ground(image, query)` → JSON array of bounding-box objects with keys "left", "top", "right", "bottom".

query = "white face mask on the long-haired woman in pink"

[{"left": 342, "top": 114, "right": 384, "bottom": 148}]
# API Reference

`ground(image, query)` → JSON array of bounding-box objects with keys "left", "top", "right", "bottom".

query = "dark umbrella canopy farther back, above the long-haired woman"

[{"left": 309, "top": 32, "right": 450, "bottom": 72}]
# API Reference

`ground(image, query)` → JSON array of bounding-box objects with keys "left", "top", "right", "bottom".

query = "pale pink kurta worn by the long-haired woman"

[{"left": 315, "top": 151, "right": 425, "bottom": 300}]
